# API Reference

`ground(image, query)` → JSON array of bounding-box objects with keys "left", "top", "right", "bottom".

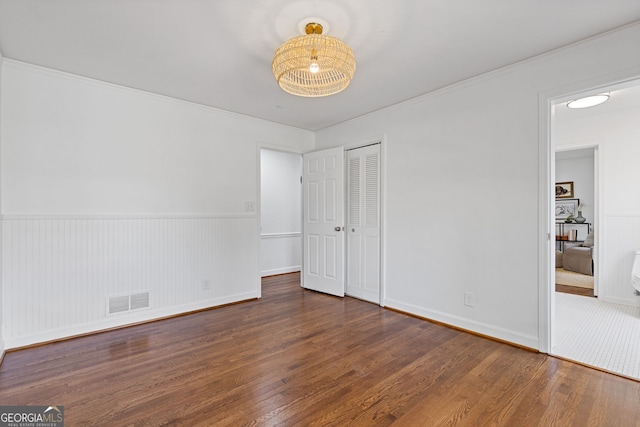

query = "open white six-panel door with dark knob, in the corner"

[{"left": 302, "top": 147, "right": 344, "bottom": 297}]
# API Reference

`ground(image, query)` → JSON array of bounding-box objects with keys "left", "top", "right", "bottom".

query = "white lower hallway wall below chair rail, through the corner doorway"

[{"left": 260, "top": 231, "right": 302, "bottom": 277}]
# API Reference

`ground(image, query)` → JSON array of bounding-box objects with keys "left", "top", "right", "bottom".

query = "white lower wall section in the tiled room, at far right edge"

[{"left": 599, "top": 215, "right": 640, "bottom": 306}]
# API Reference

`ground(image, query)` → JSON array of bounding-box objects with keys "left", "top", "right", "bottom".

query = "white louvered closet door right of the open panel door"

[{"left": 346, "top": 144, "right": 380, "bottom": 304}]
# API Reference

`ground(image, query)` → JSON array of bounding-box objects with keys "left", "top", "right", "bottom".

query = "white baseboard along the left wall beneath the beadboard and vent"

[{"left": 4, "top": 291, "right": 258, "bottom": 350}]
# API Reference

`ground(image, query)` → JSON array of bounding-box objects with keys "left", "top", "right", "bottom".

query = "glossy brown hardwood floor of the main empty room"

[{"left": 0, "top": 274, "right": 640, "bottom": 427}]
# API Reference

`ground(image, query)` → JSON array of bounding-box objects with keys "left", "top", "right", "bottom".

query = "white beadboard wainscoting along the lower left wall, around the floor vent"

[{"left": 2, "top": 216, "right": 260, "bottom": 348}]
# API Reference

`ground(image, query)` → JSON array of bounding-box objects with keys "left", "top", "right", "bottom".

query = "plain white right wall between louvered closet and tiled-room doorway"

[{"left": 316, "top": 25, "right": 640, "bottom": 348}]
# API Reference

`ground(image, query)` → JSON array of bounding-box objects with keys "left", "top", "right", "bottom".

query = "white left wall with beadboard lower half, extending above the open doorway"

[{"left": 0, "top": 60, "right": 313, "bottom": 348}]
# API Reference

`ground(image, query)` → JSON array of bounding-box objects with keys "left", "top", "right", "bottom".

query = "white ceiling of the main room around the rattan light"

[{"left": 0, "top": 0, "right": 640, "bottom": 130}]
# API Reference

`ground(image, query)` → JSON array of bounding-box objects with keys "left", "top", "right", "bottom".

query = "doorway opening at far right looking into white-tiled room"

[{"left": 548, "top": 80, "right": 640, "bottom": 379}]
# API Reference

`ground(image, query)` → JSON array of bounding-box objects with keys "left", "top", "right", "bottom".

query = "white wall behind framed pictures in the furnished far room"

[{"left": 556, "top": 150, "right": 595, "bottom": 240}]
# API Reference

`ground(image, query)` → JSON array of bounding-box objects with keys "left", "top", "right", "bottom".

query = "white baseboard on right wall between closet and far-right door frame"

[{"left": 384, "top": 298, "right": 539, "bottom": 349}]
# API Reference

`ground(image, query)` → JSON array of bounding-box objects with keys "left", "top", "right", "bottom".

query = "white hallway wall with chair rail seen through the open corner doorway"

[{"left": 260, "top": 149, "right": 302, "bottom": 276}]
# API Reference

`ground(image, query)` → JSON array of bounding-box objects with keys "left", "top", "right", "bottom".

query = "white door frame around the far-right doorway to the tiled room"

[{"left": 538, "top": 67, "right": 640, "bottom": 353}]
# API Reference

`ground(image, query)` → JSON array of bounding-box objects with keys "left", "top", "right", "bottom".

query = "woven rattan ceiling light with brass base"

[{"left": 272, "top": 22, "right": 356, "bottom": 97}]
